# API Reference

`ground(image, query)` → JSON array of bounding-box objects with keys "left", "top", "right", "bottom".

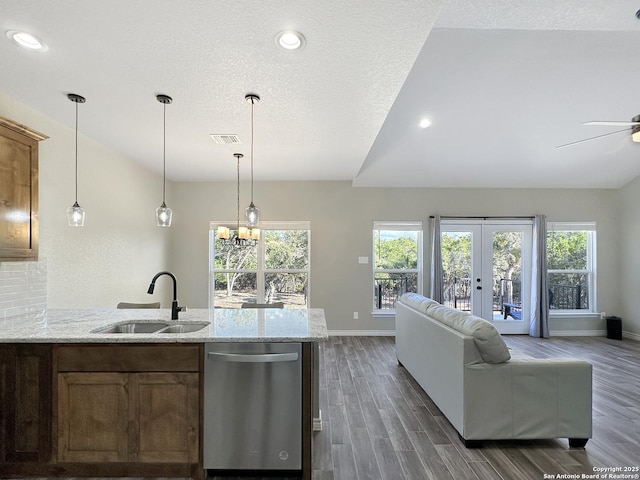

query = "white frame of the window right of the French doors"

[{"left": 546, "top": 222, "right": 598, "bottom": 316}]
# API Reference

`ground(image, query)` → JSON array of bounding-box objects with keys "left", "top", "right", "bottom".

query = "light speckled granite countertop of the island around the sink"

[{"left": 0, "top": 308, "right": 328, "bottom": 343}]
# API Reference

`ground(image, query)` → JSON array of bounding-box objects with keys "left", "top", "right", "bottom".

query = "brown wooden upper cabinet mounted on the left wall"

[{"left": 0, "top": 117, "right": 49, "bottom": 261}]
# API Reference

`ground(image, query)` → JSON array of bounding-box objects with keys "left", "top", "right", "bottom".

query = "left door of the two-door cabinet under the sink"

[{"left": 58, "top": 372, "right": 129, "bottom": 462}]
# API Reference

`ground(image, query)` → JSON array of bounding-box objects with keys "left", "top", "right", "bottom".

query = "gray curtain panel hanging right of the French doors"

[{"left": 529, "top": 215, "right": 549, "bottom": 338}]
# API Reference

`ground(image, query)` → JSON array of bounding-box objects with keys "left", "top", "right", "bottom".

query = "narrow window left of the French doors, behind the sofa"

[{"left": 373, "top": 222, "right": 422, "bottom": 313}]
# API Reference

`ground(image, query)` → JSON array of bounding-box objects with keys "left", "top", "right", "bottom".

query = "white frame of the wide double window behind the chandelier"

[{"left": 209, "top": 220, "right": 311, "bottom": 309}]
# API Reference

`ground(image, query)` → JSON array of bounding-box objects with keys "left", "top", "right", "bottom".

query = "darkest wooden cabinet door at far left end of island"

[{"left": 0, "top": 345, "right": 53, "bottom": 463}]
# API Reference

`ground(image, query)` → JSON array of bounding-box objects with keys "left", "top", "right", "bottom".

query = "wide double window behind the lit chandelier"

[{"left": 209, "top": 222, "right": 311, "bottom": 308}]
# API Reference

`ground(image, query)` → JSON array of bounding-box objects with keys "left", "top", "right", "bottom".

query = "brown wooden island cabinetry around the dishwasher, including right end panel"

[{"left": 0, "top": 343, "right": 313, "bottom": 480}]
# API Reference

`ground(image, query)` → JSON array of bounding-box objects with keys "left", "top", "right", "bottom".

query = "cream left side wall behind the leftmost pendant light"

[{"left": 0, "top": 93, "right": 170, "bottom": 308}]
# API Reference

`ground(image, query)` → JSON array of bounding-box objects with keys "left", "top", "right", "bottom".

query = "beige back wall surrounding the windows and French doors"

[{"left": 171, "top": 182, "right": 620, "bottom": 332}]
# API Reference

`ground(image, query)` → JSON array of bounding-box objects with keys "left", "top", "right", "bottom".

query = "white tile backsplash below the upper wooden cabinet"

[{"left": 0, "top": 259, "right": 47, "bottom": 319}]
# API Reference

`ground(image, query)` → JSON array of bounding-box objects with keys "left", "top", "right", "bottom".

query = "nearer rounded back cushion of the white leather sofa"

[{"left": 426, "top": 304, "right": 511, "bottom": 363}]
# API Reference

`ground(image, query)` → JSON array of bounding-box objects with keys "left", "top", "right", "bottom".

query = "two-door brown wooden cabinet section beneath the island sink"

[{"left": 56, "top": 345, "right": 201, "bottom": 475}]
